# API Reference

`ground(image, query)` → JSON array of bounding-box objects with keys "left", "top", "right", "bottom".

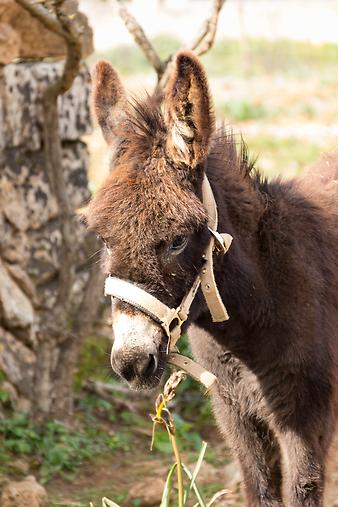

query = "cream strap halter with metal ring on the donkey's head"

[{"left": 104, "top": 176, "right": 232, "bottom": 389}]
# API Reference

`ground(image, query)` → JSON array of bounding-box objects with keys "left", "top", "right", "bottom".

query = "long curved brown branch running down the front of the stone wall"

[{"left": 16, "top": 0, "right": 81, "bottom": 314}]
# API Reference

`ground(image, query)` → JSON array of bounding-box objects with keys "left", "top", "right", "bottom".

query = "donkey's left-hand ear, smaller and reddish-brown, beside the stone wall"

[{"left": 92, "top": 60, "right": 127, "bottom": 144}]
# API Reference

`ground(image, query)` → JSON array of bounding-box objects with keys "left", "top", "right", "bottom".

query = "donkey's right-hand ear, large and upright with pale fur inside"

[{"left": 164, "top": 51, "right": 214, "bottom": 168}]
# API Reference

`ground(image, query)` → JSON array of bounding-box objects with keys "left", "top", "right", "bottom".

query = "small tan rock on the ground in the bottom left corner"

[{"left": 0, "top": 475, "right": 48, "bottom": 507}]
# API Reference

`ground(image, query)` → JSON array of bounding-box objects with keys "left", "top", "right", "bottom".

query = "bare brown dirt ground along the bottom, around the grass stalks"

[{"left": 47, "top": 435, "right": 338, "bottom": 507}]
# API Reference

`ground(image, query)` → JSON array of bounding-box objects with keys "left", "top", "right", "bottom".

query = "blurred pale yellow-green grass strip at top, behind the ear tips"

[{"left": 90, "top": 34, "right": 338, "bottom": 82}]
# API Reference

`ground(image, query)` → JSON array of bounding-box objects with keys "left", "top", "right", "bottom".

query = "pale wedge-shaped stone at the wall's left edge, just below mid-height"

[{"left": 0, "top": 260, "right": 34, "bottom": 328}]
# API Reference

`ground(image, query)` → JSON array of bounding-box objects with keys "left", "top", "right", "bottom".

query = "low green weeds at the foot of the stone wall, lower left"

[{"left": 0, "top": 408, "right": 131, "bottom": 483}]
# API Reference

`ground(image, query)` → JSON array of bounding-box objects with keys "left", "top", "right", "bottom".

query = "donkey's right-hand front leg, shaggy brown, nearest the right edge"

[{"left": 279, "top": 431, "right": 326, "bottom": 507}]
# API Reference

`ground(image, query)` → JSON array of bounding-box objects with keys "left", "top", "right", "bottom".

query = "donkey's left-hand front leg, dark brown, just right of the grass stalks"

[{"left": 215, "top": 401, "right": 283, "bottom": 507}]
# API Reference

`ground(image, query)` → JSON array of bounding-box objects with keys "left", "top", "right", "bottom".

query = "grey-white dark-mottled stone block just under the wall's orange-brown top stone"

[{"left": 0, "top": 62, "right": 91, "bottom": 153}]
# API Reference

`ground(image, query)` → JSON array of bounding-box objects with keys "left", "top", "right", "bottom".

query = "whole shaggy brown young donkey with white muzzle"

[{"left": 87, "top": 51, "right": 338, "bottom": 507}]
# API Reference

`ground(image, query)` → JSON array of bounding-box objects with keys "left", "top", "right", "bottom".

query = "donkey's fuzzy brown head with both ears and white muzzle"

[{"left": 87, "top": 51, "right": 214, "bottom": 389}]
